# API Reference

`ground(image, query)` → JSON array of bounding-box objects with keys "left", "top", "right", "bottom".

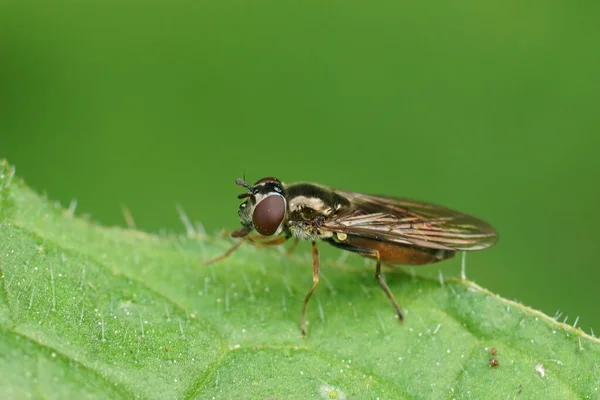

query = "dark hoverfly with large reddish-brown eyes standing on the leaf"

[{"left": 206, "top": 177, "right": 498, "bottom": 337}]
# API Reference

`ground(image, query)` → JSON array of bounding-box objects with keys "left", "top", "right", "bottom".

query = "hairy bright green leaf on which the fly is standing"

[{"left": 0, "top": 162, "right": 600, "bottom": 399}]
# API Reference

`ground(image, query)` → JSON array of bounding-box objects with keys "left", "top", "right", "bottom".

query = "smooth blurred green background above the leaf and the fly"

[{"left": 0, "top": 0, "right": 600, "bottom": 332}]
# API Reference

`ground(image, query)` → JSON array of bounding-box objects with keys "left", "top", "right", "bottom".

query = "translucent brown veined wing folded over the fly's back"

[{"left": 324, "top": 190, "right": 498, "bottom": 251}]
